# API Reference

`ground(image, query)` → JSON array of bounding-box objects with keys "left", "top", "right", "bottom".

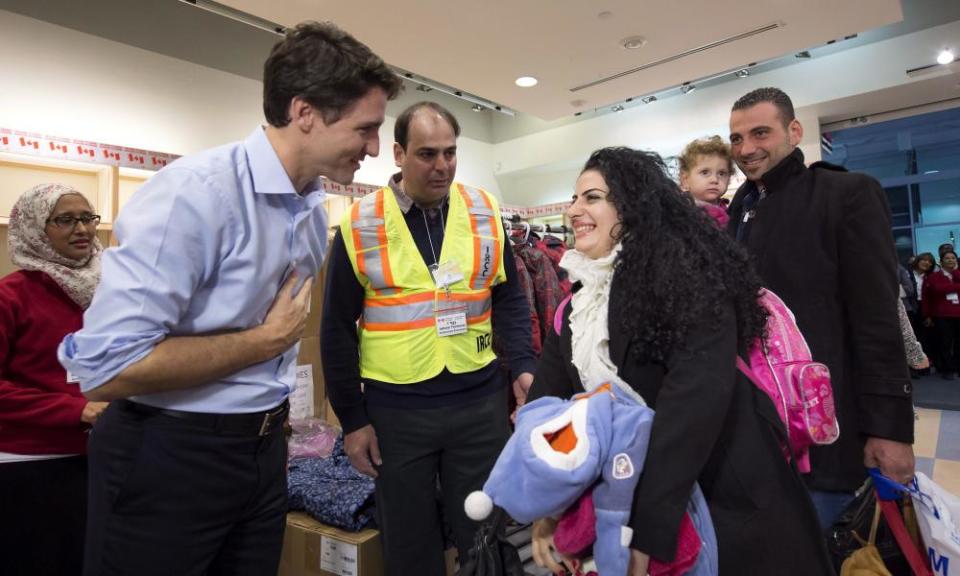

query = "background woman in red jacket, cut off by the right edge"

[{"left": 920, "top": 250, "right": 960, "bottom": 380}]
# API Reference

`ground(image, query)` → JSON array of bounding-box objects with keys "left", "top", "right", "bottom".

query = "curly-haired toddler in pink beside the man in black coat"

[{"left": 680, "top": 136, "right": 733, "bottom": 228}]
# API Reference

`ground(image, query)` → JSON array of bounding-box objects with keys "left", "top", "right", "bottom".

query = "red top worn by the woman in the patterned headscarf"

[{"left": 0, "top": 270, "right": 87, "bottom": 454}]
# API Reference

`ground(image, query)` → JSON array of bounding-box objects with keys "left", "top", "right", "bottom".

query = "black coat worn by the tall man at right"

[{"left": 728, "top": 149, "right": 913, "bottom": 491}]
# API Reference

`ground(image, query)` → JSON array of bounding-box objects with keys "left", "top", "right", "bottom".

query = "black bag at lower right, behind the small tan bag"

[{"left": 827, "top": 478, "right": 913, "bottom": 576}]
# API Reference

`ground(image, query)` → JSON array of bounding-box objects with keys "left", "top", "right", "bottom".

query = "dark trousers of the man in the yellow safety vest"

[{"left": 367, "top": 388, "right": 510, "bottom": 576}]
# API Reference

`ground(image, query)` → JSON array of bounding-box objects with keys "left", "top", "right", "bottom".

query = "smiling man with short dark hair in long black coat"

[{"left": 728, "top": 88, "right": 914, "bottom": 526}]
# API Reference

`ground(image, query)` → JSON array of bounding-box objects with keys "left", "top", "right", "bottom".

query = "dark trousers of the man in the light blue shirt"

[{"left": 84, "top": 402, "right": 287, "bottom": 576}]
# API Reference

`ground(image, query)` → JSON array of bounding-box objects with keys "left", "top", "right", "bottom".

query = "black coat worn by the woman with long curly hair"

[{"left": 528, "top": 283, "right": 833, "bottom": 576}]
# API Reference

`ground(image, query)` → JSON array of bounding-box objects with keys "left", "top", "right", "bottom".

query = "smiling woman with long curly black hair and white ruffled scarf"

[{"left": 529, "top": 148, "right": 833, "bottom": 576}]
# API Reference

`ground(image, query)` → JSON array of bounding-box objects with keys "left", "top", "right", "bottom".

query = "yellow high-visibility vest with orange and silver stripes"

[{"left": 340, "top": 183, "right": 507, "bottom": 384}]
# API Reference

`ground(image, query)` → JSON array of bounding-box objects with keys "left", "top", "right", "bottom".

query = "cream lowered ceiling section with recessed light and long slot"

[{"left": 227, "top": 0, "right": 902, "bottom": 120}]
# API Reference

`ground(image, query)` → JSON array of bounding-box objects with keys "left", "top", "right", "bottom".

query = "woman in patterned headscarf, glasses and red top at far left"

[{"left": 0, "top": 184, "right": 106, "bottom": 575}]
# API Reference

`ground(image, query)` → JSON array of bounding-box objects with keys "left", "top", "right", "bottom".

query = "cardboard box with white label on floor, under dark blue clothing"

[{"left": 279, "top": 512, "right": 383, "bottom": 576}]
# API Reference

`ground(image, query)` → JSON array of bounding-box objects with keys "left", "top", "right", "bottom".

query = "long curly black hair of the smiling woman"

[{"left": 583, "top": 147, "right": 767, "bottom": 363}]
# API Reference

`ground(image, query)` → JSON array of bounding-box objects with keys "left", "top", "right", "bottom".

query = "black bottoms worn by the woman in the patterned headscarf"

[{"left": 0, "top": 456, "right": 87, "bottom": 576}]
